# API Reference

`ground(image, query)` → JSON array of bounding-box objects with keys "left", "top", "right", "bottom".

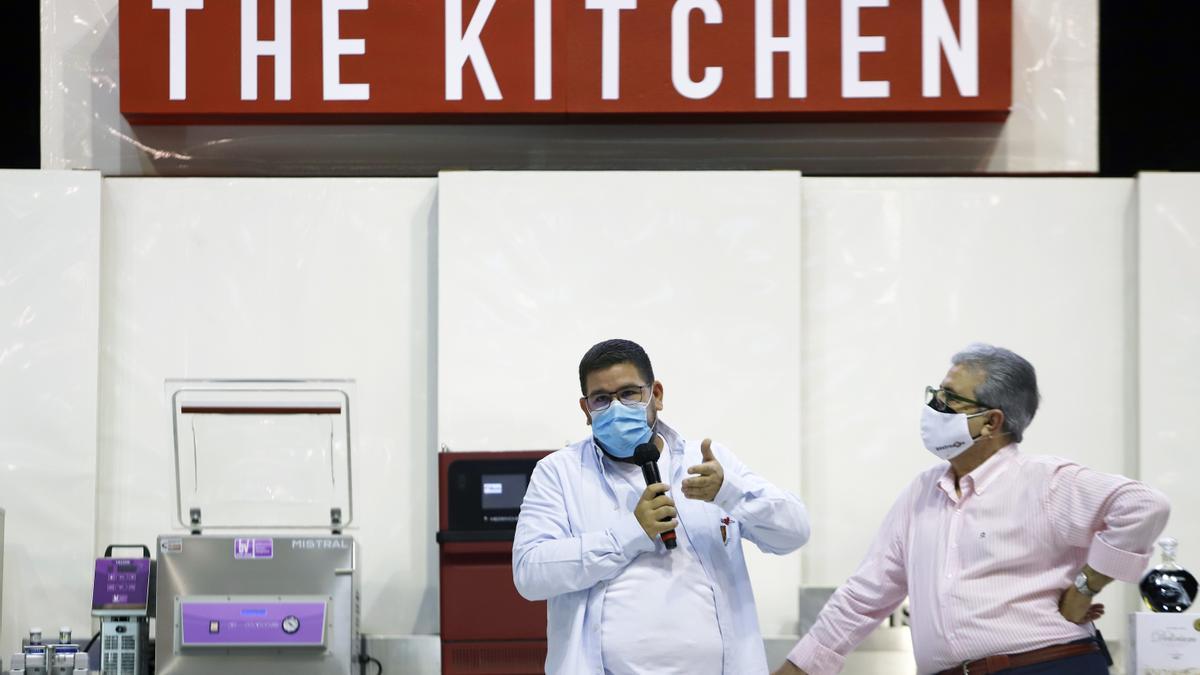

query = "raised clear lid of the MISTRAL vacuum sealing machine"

[{"left": 167, "top": 380, "right": 356, "bottom": 530}]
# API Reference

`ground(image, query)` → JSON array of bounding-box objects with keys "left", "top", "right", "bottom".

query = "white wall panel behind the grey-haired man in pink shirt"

[{"left": 802, "top": 179, "right": 1135, "bottom": 638}]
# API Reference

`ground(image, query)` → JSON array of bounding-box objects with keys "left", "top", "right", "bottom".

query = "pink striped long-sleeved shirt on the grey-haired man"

[{"left": 788, "top": 444, "right": 1170, "bottom": 675}]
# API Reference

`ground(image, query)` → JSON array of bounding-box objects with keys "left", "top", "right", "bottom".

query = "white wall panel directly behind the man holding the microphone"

[{"left": 438, "top": 172, "right": 800, "bottom": 634}]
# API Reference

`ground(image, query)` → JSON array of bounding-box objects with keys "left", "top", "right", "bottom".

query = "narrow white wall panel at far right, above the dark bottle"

[{"left": 1138, "top": 173, "right": 1200, "bottom": 557}]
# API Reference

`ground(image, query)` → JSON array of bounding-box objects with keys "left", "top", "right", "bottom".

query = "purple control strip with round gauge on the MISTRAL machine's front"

[{"left": 179, "top": 601, "right": 325, "bottom": 647}]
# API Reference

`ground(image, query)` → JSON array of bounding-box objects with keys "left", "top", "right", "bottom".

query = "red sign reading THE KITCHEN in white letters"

[{"left": 120, "top": 0, "right": 1012, "bottom": 123}]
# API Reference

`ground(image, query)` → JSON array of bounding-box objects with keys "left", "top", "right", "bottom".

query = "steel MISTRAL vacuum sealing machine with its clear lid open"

[{"left": 155, "top": 381, "right": 360, "bottom": 675}]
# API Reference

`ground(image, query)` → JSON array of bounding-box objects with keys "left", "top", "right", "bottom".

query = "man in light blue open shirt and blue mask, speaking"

[{"left": 512, "top": 340, "right": 809, "bottom": 675}]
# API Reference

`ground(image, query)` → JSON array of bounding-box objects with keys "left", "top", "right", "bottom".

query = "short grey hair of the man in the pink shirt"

[{"left": 950, "top": 342, "right": 1042, "bottom": 442}]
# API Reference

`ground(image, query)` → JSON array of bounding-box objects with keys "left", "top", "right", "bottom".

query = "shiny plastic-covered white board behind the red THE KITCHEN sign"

[{"left": 42, "top": 0, "right": 1099, "bottom": 175}]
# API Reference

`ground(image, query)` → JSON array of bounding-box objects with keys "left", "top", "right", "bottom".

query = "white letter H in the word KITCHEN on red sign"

[{"left": 754, "top": 0, "right": 809, "bottom": 98}]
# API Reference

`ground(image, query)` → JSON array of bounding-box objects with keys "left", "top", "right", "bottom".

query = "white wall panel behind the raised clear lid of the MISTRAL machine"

[{"left": 97, "top": 179, "right": 438, "bottom": 633}]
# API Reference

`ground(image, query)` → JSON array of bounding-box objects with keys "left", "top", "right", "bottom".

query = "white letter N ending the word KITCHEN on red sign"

[{"left": 920, "top": 0, "right": 979, "bottom": 98}]
